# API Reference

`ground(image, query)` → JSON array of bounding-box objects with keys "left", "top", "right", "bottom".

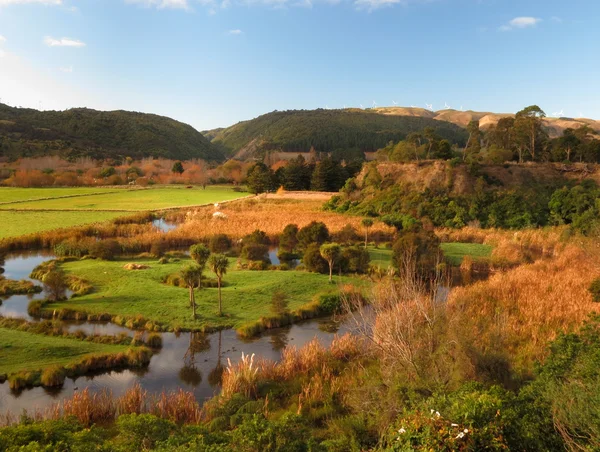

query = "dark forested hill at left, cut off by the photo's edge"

[{"left": 0, "top": 104, "right": 224, "bottom": 161}]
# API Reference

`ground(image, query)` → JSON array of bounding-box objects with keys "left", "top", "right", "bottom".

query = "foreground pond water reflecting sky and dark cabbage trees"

[{"left": 0, "top": 312, "right": 349, "bottom": 415}]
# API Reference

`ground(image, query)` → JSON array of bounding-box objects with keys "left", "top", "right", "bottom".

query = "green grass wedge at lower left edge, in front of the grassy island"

[{"left": 0, "top": 328, "right": 128, "bottom": 375}]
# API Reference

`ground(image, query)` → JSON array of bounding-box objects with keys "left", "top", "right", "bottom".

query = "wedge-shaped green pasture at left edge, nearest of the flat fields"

[{"left": 0, "top": 211, "right": 123, "bottom": 239}]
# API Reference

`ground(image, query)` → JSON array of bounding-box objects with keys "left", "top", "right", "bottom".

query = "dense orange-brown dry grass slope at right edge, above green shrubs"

[{"left": 449, "top": 240, "right": 600, "bottom": 370}]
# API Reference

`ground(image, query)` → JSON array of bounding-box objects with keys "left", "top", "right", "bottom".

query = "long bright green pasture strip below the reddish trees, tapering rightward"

[{"left": 0, "top": 187, "right": 247, "bottom": 211}]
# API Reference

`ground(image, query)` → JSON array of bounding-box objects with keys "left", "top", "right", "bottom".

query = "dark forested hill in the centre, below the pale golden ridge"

[{"left": 205, "top": 109, "right": 468, "bottom": 159}]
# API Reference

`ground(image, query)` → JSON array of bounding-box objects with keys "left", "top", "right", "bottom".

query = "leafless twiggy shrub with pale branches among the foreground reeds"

[{"left": 344, "top": 250, "right": 456, "bottom": 386}]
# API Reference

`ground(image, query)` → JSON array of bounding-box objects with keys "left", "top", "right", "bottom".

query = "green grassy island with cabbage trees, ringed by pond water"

[{"left": 51, "top": 259, "right": 365, "bottom": 329}]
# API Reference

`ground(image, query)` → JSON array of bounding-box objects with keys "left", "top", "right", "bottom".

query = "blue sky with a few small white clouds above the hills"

[{"left": 0, "top": 0, "right": 600, "bottom": 130}]
